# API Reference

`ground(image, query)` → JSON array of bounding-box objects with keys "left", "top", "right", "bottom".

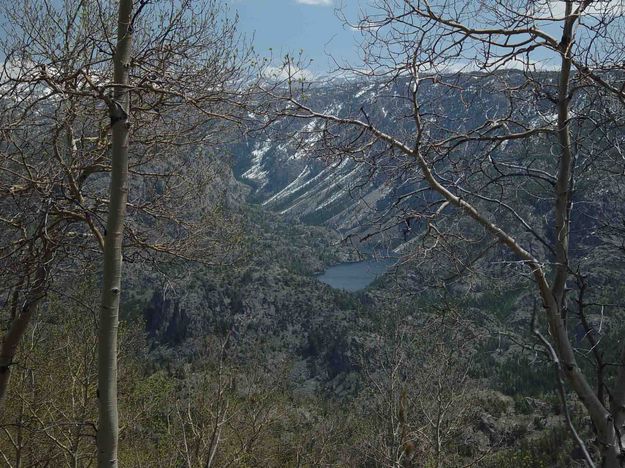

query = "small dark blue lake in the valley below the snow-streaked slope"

[{"left": 317, "top": 259, "right": 396, "bottom": 292}]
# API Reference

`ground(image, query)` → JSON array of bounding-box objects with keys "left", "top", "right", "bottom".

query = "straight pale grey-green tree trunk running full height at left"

[{"left": 97, "top": 0, "right": 133, "bottom": 467}]
